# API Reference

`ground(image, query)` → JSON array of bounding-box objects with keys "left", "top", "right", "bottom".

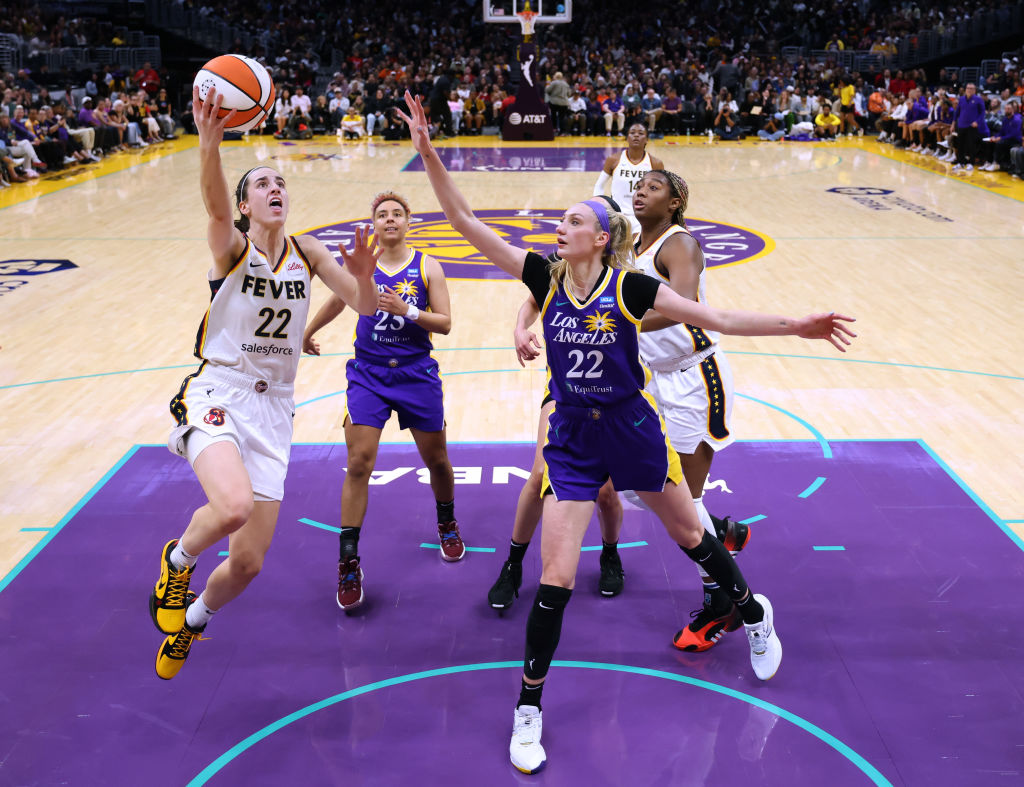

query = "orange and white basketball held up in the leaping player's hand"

[{"left": 193, "top": 54, "right": 274, "bottom": 131}]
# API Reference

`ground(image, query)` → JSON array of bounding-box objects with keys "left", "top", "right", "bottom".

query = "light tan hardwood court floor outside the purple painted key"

[{"left": 0, "top": 132, "right": 1024, "bottom": 587}]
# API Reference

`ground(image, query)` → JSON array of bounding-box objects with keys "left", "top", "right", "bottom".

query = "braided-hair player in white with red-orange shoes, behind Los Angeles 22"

[{"left": 626, "top": 170, "right": 750, "bottom": 651}]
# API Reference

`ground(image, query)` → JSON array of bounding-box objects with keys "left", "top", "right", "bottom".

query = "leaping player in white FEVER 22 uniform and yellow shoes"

[{"left": 150, "top": 82, "right": 380, "bottom": 680}]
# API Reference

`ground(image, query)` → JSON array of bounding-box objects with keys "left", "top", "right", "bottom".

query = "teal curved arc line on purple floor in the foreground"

[{"left": 187, "top": 661, "right": 892, "bottom": 787}]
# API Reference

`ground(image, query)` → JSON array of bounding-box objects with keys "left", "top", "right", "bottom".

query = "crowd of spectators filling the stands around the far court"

[{"left": 3, "top": 0, "right": 1024, "bottom": 182}]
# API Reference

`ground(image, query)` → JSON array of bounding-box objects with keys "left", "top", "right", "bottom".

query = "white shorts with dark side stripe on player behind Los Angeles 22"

[{"left": 646, "top": 352, "right": 735, "bottom": 454}]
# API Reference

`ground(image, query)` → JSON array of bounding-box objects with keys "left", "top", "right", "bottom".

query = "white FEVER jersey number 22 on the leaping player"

[{"left": 196, "top": 235, "right": 311, "bottom": 383}]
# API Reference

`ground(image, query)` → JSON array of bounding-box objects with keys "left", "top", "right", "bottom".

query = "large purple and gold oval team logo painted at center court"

[{"left": 304, "top": 209, "right": 775, "bottom": 279}]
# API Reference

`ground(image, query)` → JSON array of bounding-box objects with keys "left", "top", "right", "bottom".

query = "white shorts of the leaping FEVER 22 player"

[{"left": 167, "top": 363, "right": 295, "bottom": 500}]
